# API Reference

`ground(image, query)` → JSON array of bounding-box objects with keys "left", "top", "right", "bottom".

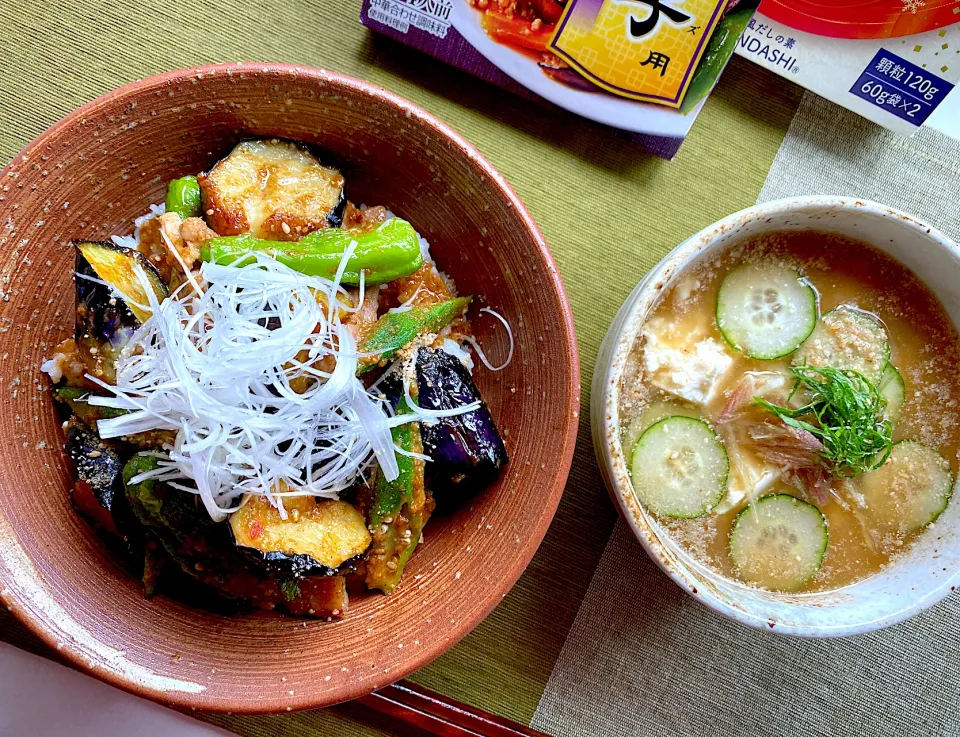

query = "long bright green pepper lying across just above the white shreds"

[{"left": 200, "top": 218, "right": 423, "bottom": 285}]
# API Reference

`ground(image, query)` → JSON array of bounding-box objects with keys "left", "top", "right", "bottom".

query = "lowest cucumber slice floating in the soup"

[{"left": 730, "top": 494, "right": 830, "bottom": 591}]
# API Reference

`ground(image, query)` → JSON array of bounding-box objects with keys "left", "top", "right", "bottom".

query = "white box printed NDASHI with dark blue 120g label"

[{"left": 737, "top": 0, "right": 960, "bottom": 137}]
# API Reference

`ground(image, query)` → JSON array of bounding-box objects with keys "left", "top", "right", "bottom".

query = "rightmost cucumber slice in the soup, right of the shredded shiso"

[{"left": 860, "top": 440, "right": 953, "bottom": 535}]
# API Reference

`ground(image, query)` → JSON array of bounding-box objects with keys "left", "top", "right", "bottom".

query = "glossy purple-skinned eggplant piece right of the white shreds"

[{"left": 417, "top": 348, "right": 509, "bottom": 501}]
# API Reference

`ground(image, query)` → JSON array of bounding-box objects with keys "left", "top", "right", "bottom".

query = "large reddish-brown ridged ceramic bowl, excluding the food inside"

[{"left": 0, "top": 64, "right": 579, "bottom": 713}]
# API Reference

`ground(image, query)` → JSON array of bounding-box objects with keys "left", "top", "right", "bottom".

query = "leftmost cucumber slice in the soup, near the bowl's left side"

[{"left": 630, "top": 415, "right": 729, "bottom": 517}]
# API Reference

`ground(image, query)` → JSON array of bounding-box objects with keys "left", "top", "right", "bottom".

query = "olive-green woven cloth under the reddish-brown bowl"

[{"left": 0, "top": 0, "right": 799, "bottom": 737}]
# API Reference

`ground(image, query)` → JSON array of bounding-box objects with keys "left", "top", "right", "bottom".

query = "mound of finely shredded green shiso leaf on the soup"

[{"left": 754, "top": 366, "right": 893, "bottom": 478}]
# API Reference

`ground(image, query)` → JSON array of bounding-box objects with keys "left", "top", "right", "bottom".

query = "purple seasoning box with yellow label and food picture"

[{"left": 360, "top": 0, "right": 759, "bottom": 159}]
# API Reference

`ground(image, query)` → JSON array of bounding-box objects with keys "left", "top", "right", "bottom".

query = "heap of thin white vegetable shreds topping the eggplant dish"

[{"left": 88, "top": 248, "right": 477, "bottom": 521}]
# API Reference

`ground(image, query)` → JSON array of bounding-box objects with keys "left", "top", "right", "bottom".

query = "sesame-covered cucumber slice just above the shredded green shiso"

[{"left": 793, "top": 305, "right": 890, "bottom": 384}]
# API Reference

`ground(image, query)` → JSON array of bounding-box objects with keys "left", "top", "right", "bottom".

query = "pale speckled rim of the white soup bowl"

[{"left": 590, "top": 195, "right": 960, "bottom": 638}]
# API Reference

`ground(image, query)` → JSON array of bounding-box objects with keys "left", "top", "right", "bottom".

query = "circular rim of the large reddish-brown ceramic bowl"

[{"left": 0, "top": 61, "right": 580, "bottom": 715}]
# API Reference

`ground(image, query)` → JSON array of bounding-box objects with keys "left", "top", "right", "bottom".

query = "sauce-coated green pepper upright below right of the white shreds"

[{"left": 366, "top": 399, "right": 433, "bottom": 594}]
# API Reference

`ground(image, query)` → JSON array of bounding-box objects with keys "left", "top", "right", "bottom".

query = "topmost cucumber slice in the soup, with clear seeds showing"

[{"left": 717, "top": 265, "right": 817, "bottom": 360}]
